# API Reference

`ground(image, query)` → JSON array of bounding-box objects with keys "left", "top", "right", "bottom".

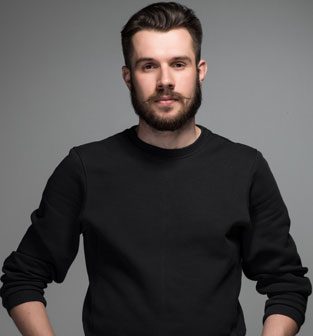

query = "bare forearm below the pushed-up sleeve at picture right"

[{"left": 261, "top": 314, "right": 298, "bottom": 336}]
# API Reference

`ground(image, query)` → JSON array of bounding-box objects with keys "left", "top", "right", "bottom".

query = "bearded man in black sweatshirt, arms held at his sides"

[{"left": 1, "top": 2, "right": 311, "bottom": 336}]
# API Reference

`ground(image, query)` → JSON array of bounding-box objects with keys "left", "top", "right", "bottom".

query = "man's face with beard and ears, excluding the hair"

[{"left": 124, "top": 28, "right": 206, "bottom": 131}]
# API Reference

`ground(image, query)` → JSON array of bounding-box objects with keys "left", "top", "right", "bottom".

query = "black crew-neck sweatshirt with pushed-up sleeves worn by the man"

[{"left": 0, "top": 124, "right": 311, "bottom": 336}]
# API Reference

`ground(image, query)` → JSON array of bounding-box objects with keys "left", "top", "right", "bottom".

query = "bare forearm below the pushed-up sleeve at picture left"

[{"left": 10, "top": 301, "right": 54, "bottom": 336}]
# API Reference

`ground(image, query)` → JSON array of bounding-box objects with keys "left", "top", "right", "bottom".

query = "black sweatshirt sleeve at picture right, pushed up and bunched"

[{"left": 242, "top": 151, "right": 312, "bottom": 329}]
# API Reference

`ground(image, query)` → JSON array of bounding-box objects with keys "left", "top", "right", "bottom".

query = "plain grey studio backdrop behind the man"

[{"left": 0, "top": 0, "right": 313, "bottom": 336}]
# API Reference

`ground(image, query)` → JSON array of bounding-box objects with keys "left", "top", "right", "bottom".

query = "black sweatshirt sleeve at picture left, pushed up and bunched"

[{"left": 0, "top": 148, "right": 85, "bottom": 312}]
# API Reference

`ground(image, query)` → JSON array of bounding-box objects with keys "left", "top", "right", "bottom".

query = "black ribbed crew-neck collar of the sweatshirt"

[{"left": 125, "top": 124, "right": 212, "bottom": 158}]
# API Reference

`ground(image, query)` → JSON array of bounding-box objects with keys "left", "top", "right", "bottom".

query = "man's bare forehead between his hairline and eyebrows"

[{"left": 132, "top": 28, "right": 194, "bottom": 61}]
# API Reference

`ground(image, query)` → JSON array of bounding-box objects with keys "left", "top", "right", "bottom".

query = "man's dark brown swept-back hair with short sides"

[{"left": 121, "top": 2, "right": 202, "bottom": 69}]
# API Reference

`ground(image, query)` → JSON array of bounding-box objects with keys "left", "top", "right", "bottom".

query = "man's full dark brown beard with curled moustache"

[{"left": 130, "top": 77, "right": 202, "bottom": 131}]
